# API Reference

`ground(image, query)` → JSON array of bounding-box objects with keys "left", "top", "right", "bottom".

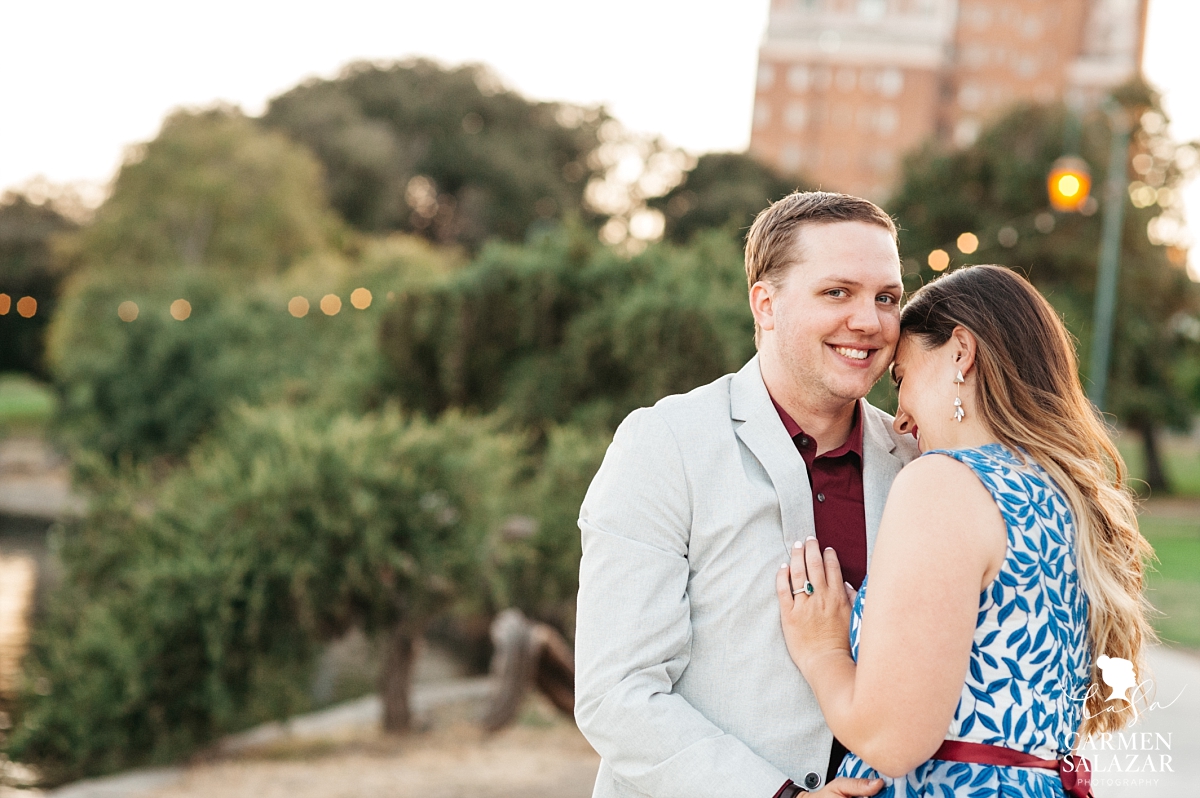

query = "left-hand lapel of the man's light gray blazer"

[{"left": 730, "top": 355, "right": 816, "bottom": 552}]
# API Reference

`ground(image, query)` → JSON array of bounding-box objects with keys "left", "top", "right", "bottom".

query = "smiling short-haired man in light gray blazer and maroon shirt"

[{"left": 575, "top": 192, "right": 917, "bottom": 798}]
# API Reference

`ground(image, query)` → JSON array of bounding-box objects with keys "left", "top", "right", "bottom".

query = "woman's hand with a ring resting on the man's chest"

[{"left": 775, "top": 536, "right": 854, "bottom": 682}]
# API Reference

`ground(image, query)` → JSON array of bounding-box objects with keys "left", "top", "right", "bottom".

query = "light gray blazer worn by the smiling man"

[{"left": 575, "top": 356, "right": 917, "bottom": 798}]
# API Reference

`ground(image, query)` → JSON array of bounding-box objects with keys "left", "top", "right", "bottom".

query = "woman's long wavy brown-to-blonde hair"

[{"left": 900, "top": 266, "right": 1154, "bottom": 740}]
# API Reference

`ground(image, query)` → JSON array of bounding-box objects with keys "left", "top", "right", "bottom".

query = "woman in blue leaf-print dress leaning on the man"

[{"left": 776, "top": 266, "right": 1153, "bottom": 797}]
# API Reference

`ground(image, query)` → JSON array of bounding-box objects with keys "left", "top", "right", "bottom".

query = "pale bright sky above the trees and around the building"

[{"left": 0, "top": 0, "right": 1200, "bottom": 273}]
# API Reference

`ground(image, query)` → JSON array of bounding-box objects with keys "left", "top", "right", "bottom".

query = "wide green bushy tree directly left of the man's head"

[{"left": 380, "top": 220, "right": 754, "bottom": 433}]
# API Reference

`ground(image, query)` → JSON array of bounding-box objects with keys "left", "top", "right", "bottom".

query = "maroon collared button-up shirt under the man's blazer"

[{"left": 770, "top": 398, "right": 866, "bottom": 590}]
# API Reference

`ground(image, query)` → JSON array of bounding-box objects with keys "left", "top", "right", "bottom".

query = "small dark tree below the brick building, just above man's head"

[{"left": 649, "top": 152, "right": 804, "bottom": 244}]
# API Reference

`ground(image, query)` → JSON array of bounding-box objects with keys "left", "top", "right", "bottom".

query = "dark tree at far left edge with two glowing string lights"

[{"left": 0, "top": 193, "right": 76, "bottom": 378}]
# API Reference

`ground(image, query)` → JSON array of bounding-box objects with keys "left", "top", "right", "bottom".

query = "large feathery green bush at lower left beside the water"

[{"left": 5, "top": 408, "right": 522, "bottom": 781}]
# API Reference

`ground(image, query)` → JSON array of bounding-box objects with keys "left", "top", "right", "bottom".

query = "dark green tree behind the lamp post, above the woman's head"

[{"left": 889, "top": 84, "right": 1200, "bottom": 490}]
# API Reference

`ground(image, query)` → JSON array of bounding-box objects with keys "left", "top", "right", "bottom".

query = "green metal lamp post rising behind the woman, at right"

[{"left": 1088, "top": 100, "right": 1132, "bottom": 412}]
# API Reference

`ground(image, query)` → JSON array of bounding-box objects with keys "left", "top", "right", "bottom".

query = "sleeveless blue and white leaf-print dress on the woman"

[{"left": 839, "top": 444, "right": 1091, "bottom": 798}]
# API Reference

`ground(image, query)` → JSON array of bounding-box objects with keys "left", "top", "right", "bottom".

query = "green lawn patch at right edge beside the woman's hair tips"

[{"left": 1140, "top": 511, "right": 1200, "bottom": 649}]
